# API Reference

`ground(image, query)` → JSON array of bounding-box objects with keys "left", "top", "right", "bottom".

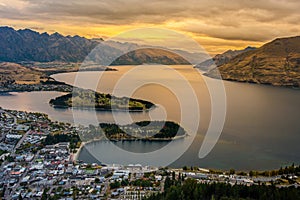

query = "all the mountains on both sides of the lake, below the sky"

[{"left": 0, "top": 27, "right": 300, "bottom": 87}]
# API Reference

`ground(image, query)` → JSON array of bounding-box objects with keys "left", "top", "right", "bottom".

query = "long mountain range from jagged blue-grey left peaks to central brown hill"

[{"left": 0, "top": 27, "right": 199, "bottom": 65}]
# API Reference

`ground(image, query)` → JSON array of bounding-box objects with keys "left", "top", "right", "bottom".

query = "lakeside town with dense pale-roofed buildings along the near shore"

[{"left": 0, "top": 109, "right": 300, "bottom": 199}]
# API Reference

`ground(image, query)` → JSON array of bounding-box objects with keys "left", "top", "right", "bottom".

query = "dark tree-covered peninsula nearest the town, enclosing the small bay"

[{"left": 100, "top": 121, "right": 187, "bottom": 141}]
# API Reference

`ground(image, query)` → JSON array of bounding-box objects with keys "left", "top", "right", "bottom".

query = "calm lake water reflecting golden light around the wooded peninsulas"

[{"left": 0, "top": 66, "right": 300, "bottom": 170}]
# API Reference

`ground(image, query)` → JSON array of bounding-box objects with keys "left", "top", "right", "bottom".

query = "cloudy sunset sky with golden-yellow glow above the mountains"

[{"left": 0, "top": 0, "right": 300, "bottom": 55}]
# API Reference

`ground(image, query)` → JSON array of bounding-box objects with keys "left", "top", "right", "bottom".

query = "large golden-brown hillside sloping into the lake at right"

[{"left": 206, "top": 36, "right": 300, "bottom": 87}]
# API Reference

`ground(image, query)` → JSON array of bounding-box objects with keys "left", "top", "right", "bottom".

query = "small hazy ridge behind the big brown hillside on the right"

[{"left": 195, "top": 46, "right": 256, "bottom": 71}]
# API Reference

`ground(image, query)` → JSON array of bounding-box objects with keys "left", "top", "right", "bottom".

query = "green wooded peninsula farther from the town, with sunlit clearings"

[{"left": 49, "top": 88, "right": 154, "bottom": 111}]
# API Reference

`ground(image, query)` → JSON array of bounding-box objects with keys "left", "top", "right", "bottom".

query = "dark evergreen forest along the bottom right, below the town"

[{"left": 147, "top": 177, "right": 300, "bottom": 200}]
